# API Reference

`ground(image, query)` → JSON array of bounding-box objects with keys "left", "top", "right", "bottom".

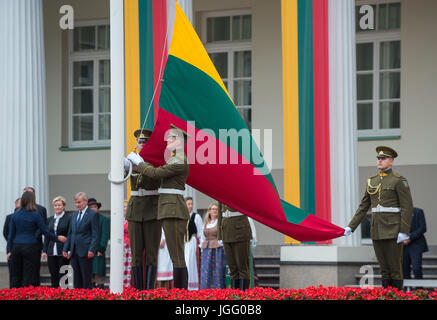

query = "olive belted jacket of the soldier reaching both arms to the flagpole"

[{"left": 138, "top": 154, "right": 190, "bottom": 220}]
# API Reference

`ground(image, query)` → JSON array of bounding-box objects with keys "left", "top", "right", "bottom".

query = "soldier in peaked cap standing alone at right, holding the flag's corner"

[{"left": 345, "top": 146, "right": 413, "bottom": 290}]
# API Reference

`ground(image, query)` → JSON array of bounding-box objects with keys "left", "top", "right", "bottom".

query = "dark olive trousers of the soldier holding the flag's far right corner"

[{"left": 373, "top": 239, "right": 403, "bottom": 280}]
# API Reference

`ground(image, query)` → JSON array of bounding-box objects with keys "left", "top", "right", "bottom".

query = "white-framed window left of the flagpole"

[{"left": 69, "top": 22, "right": 111, "bottom": 147}]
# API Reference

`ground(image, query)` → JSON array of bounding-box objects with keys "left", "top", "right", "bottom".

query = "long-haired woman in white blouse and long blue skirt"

[{"left": 200, "top": 203, "right": 226, "bottom": 289}]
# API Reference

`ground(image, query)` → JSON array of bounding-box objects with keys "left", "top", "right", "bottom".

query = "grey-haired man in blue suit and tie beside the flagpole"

[{"left": 62, "top": 192, "right": 100, "bottom": 289}]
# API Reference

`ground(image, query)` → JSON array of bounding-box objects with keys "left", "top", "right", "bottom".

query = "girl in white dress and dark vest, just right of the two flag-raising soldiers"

[{"left": 185, "top": 197, "right": 203, "bottom": 290}]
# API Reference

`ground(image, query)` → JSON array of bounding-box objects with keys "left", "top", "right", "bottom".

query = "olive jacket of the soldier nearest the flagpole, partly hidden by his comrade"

[{"left": 126, "top": 162, "right": 160, "bottom": 222}]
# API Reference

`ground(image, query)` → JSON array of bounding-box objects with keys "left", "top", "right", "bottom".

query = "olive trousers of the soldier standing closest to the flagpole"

[{"left": 128, "top": 220, "right": 161, "bottom": 267}]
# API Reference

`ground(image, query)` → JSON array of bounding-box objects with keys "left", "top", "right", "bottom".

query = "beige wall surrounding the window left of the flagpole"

[{"left": 43, "top": 0, "right": 110, "bottom": 176}]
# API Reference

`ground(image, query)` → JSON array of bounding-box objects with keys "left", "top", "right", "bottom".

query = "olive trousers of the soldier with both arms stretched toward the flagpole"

[{"left": 160, "top": 218, "right": 188, "bottom": 268}]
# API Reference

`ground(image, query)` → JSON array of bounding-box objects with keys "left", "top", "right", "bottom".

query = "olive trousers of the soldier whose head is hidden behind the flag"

[{"left": 223, "top": 240, "right": 250, "bottom": 279}]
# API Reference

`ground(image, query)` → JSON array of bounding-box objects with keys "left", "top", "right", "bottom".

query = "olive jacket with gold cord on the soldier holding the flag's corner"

[{"left": 349, "top": 170, "right": 413, "bottom": 240}]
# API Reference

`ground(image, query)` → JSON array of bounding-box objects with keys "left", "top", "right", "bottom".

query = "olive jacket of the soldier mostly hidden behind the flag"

[{"left": 217, "top": 203, "right": 252, "bottom": 242}]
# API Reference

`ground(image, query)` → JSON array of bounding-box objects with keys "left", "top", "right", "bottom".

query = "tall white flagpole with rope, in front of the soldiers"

[{"left": 110, "top": 0, "right": 125, "bottom": 293}]
